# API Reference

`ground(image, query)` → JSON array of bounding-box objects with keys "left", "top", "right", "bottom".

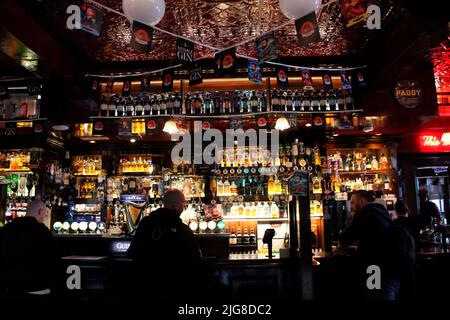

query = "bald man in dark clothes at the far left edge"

[{"left": 0, "top": 200, "right": 56, "bottom": 298}]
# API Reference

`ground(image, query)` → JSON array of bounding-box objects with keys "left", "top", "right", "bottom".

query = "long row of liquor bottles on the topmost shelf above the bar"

[{"left": 95, "top": 84, "right": 359, "bottom": 117}]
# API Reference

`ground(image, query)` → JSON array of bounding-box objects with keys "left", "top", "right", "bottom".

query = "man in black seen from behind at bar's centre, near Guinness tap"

[{"left": 128, "top": 189, "right": 202, "bottom": 300}]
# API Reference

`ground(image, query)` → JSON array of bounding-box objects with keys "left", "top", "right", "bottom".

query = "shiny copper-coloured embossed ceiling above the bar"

[{"left": 32, "top": 0, "right": 398, "bottom": 62}]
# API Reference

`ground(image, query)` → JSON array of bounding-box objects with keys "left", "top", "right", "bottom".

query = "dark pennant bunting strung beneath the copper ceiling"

[{"left": 80, "top": 0, "right": 366, "bottom": 87}]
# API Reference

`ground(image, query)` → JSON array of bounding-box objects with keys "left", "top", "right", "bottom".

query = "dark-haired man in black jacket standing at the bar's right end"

[{"left": 339, "top": 190, "right": 400, "bottom": 300}]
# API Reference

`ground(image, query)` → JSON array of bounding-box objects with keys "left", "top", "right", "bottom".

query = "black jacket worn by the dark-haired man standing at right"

[{"left": 339, "top": 203, "right": 392, "bottom": 265}]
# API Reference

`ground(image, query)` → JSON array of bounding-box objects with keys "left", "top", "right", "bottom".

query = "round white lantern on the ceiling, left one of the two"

[{"left": 122, "top": 0, "right": 166, "bottom": 26}]
